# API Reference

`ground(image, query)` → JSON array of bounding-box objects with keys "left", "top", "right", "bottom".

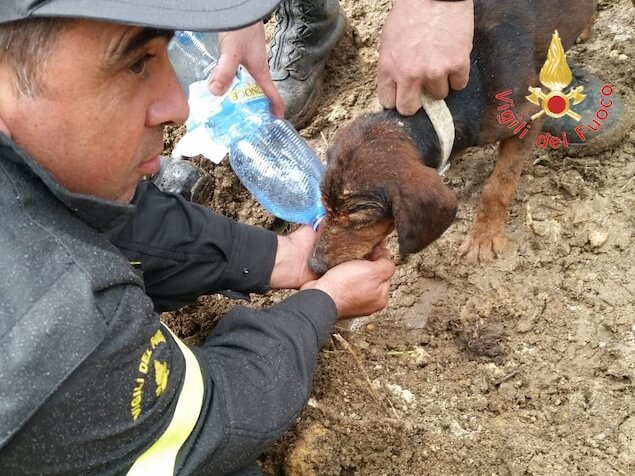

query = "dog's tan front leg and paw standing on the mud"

[{"left": 460, "top": 121, "right": 542, "bottom": 263}]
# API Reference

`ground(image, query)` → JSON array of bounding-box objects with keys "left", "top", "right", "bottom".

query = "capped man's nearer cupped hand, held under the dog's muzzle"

[{"left": 300, "top": 242, "right": 395, "bottom": 319}]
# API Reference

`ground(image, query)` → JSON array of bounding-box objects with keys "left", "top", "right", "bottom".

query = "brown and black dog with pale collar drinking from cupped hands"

[{"left": 311, "top": 0, "right": 597, "bottom": 272}]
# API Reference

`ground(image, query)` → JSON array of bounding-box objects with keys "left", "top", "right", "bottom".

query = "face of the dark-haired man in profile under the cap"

[{"left": 0, "top": 21, "right": 188, "bottom": 202}]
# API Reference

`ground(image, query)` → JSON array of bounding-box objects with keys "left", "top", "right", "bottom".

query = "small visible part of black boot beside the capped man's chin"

[{"left": 152, "top": 157, "right": 214, "bottom": 205}]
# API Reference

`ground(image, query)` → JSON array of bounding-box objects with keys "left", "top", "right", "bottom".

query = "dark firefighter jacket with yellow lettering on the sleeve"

[{"left": 0, "top": 134, "right": 336, "bottom": 475}]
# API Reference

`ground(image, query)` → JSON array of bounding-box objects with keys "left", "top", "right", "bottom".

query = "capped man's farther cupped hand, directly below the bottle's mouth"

[{"left": 269, "top": 226, "right": 318, "bottom": 289}]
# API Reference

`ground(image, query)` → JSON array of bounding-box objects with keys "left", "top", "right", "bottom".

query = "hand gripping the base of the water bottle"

[{"left": 209, "top": 22, "right": 284, "bottom": 118}]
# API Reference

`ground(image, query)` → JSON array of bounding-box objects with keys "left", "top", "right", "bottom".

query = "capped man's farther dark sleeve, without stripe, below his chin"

[{"left": 108, "top": 181, "right": 278, "bottom": 312}]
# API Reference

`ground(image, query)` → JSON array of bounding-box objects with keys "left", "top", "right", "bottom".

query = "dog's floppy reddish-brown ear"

[{"left": 391, "top": 166, "right": 457, "bottom": 254}]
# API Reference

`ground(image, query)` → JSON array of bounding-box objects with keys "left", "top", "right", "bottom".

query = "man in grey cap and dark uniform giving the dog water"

[{"left": 0, "top": 0, "right": 394, "bottom": 475}]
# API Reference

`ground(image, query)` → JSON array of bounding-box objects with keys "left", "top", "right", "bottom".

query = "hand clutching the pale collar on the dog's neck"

[{"left": 377, "top": 0, "right": 474, "bottom": 116}]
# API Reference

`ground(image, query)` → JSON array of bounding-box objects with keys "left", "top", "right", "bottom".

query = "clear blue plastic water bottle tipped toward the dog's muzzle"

[{"left": 168, "top": 31, "right": 326, "bottom": 228}]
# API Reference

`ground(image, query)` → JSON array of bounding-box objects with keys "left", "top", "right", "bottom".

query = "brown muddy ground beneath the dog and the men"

[{"left": 163, "top": 0, "right": 635, "bottom": 476}]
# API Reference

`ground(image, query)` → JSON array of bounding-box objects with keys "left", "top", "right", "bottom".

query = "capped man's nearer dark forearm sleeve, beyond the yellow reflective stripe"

[{"left": 182, "top": 290, "right": 336, "bottom": 474}]
